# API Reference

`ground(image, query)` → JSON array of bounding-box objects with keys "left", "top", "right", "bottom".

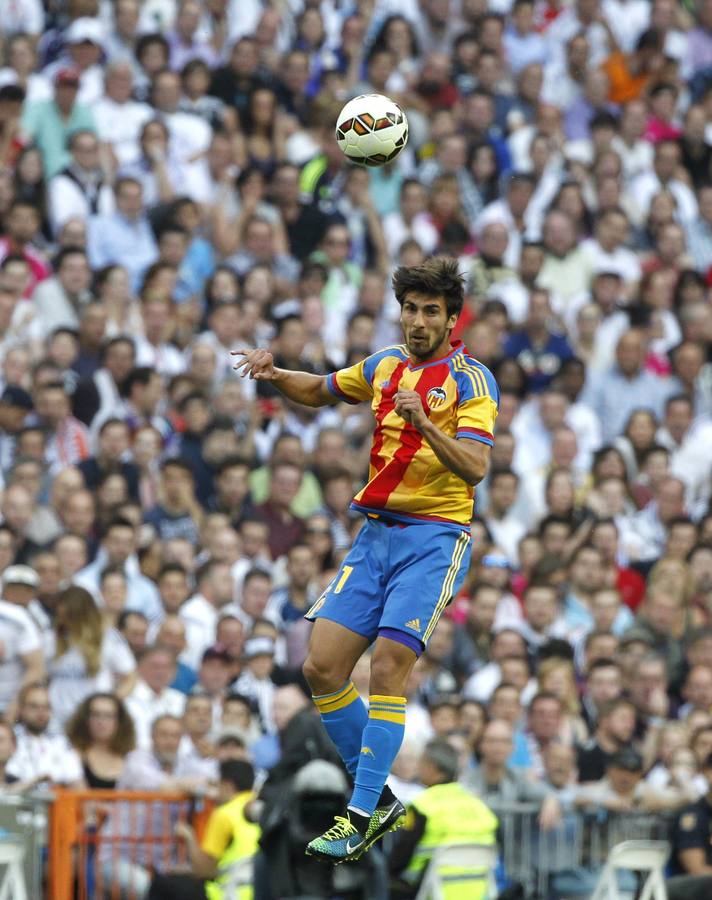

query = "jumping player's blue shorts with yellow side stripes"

[{"left": 306, "top": 516, "right": 471, "bottom": 649}]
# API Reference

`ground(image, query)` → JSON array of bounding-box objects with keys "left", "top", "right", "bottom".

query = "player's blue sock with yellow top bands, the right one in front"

[{"left": 349, "top": 694, "right": 406, "bottom": 816}]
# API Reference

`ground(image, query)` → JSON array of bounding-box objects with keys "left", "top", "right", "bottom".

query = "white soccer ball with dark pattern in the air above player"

[{"left": 336, "top": 94, "right": 408, "bottom": 166}]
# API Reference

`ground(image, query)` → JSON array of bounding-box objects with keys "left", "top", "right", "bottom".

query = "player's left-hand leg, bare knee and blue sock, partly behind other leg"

[{"left": 303, "top": 618, "right": 369, "bottom": 777}]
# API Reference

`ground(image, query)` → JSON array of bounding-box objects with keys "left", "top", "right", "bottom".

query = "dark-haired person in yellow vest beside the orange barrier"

[{"left": 147, "top": 760, "right": 260, "bottom": 900}]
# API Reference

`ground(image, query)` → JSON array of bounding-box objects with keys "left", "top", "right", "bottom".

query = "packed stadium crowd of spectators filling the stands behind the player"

[{"left": 0, "top": 0, "right": 712, "bottom": 892}]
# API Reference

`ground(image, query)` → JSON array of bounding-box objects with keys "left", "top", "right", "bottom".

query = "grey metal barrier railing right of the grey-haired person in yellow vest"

[{"left": 490, "top": 803, "right": 671, "bottom": 900}]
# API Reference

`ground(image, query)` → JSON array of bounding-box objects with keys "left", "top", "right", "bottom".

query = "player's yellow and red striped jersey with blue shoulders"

[{"left": 327, "top": 341, "right": 499, "bottom": 528}]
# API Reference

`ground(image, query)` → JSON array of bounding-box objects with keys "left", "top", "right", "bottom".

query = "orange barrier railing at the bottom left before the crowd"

[{"left": 49, "top": 790, "right": 209, "bottom": 900}]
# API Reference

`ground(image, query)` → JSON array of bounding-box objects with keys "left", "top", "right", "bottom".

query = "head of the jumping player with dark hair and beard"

[{"left": 393, "top": 258, "right": 463, "bottom": 359}]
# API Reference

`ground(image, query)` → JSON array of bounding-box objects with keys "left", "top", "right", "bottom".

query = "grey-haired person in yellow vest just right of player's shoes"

[{"left": 388, "top": 739, "right": 499, "bottom": 900}]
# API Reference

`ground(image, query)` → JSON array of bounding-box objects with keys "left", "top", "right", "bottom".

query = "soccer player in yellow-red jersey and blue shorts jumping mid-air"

[{"left": 233, "top": 259, "right": 499, "bottom": 864}]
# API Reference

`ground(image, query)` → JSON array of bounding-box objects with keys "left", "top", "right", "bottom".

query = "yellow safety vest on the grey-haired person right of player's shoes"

[{"left": 403, "top": 781, "right": 499, "bottom": 900}]
